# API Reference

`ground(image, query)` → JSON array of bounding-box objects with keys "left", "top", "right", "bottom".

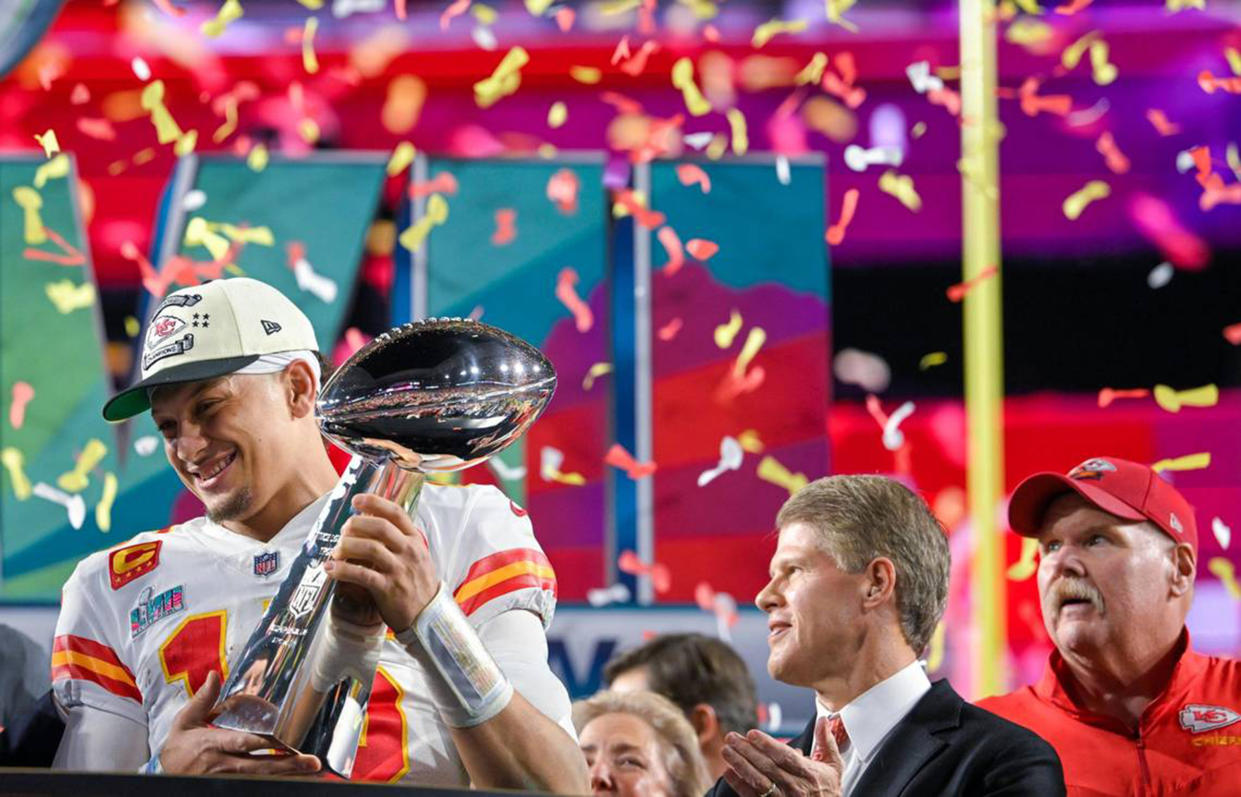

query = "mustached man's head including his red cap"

[{"left": 1009, "top": 457, "right": 1198, "bottom": 674}]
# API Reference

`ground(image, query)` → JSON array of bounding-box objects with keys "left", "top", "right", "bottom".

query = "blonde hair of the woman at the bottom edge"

[{"left": 573, "top": 691, "right": 711, "bottom": 797}]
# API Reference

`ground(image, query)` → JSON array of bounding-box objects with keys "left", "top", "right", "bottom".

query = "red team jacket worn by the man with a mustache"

[{"left": 978, "top": 632, "right": 1241, "bottom": 797}]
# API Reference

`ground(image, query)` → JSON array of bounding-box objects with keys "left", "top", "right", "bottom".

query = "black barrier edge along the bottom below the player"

[{"left": 0, "top": 768, "right": 531, "bottom": 797}]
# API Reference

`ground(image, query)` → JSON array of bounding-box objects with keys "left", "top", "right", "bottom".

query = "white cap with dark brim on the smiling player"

[{"left": 103, "top": 277, "right": 319, "bottom": 421}]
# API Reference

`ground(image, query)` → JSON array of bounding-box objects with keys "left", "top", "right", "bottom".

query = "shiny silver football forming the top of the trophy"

[{"left": 316, "top": 318, "right": 556, "bottom": 473}]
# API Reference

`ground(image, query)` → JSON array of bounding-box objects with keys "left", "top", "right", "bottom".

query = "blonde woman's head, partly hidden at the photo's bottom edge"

[{"left": 573, "top": 691, "right": 710, "bottom": 797}]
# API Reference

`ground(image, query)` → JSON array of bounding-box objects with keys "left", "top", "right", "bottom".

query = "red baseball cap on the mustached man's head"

[{"left": 1009, "top": 457, "right": 1198, "bottom": 554}]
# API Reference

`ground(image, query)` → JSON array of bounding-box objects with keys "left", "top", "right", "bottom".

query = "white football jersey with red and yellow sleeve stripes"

[{"left": 52, "top": 484, "right": 572, "bottom": 786}]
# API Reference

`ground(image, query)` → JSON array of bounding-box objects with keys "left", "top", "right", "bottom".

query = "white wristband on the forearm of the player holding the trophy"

[{"left": 396, "top": 583, "right": 513, "bottom": 727}]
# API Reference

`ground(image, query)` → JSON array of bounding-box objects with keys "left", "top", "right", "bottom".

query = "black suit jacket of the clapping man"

[{"left": 707, "top": 680, "right": 1065, "bottom": 797}]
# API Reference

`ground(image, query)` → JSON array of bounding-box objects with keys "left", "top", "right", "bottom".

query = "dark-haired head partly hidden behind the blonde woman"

[{"left": 603, "top": 633, "right": 758, "bottom": 777}]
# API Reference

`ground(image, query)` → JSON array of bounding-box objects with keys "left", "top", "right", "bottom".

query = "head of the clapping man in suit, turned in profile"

[{"left": 755, "top": 475, "right": 949, "bottom": 709}]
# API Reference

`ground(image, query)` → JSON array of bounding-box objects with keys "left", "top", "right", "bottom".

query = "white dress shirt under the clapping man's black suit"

[{"left": 812, "top": 662, "right": 931, "bottom": 797}]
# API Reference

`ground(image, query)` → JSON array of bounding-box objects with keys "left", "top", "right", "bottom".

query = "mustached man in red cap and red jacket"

[{"left": 979, "top": 457, "right": 1241, "bottom": 795}]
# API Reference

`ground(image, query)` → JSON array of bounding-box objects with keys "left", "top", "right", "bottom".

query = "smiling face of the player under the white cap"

[{"left": 151, "top": 374, "right": 292, "bottom": 523}]
